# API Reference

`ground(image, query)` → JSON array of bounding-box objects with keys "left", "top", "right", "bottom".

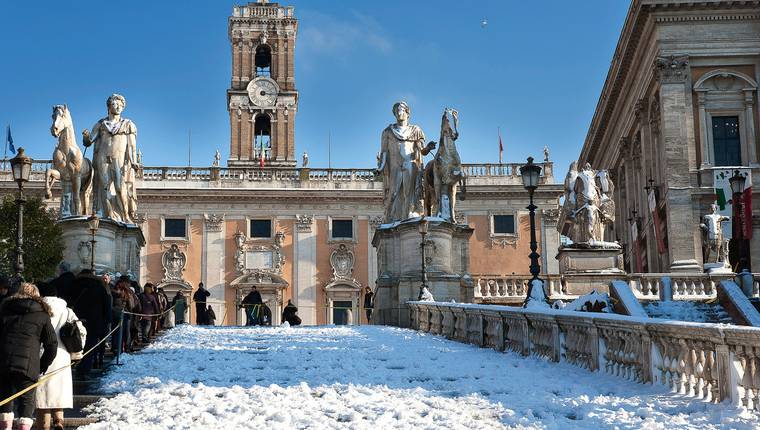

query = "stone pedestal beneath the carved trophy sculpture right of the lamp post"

[{"left": 557, "top": 246, "right": 625, "bottom": 296}]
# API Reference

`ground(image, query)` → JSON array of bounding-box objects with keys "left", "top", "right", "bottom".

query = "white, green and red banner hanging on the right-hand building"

[{"left": 713, "top": 167, "right": 752, "bottom": 239}]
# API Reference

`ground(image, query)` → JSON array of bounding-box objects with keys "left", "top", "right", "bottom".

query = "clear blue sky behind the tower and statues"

[{"left": 0, "top": 0, "right": 629, "bottom": 173}]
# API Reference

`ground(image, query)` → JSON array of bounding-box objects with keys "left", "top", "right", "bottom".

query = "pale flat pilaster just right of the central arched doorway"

[{"left": 293, "top": 215, "right": 318, "bottom": 325}]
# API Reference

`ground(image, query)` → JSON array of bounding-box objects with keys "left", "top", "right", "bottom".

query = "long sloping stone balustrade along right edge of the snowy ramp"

[{"left": 408, "top": 302, "right": 760, "bottom": 408}]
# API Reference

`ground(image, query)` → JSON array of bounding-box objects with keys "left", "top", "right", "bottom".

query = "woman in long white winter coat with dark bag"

[{"left": 36, "top": 283, "right": 87, "bottom": 430}]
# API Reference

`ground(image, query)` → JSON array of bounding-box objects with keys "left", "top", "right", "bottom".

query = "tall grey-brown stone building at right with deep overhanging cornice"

[{"left": 579, "top": 0, "right": 760, "bottom": 272}]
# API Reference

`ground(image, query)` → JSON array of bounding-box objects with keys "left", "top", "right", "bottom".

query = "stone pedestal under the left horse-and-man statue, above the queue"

[{"left": 58, "top": 216, "right": 145, "bottom": 279}]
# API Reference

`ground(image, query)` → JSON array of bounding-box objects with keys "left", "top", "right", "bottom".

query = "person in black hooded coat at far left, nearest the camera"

[{"left": 0, "top": 283, "right": 58, "bottom": 428}]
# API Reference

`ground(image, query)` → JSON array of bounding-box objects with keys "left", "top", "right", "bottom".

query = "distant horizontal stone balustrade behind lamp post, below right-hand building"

[{"left": 472, "top": 273, "right": 760, "bottom": 304}]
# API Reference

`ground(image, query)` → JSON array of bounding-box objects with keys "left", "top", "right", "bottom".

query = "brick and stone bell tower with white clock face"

[{"left": 227, "top": 0, "right": 298, "bottom": 167}]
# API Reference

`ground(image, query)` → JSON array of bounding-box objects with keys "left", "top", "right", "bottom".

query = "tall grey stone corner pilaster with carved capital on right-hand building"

[{"left": 654, "top": 56, "right": 702, "bottom": 272}]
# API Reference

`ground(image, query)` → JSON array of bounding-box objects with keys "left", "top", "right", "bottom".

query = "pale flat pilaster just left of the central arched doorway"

[{"left": 201, "top": 214, "right": 226, "bottom": 325}]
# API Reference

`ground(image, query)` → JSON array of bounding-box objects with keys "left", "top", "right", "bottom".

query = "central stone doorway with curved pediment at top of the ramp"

[{"left": 230, "top": 271, "right": 288, "bottom": 325}]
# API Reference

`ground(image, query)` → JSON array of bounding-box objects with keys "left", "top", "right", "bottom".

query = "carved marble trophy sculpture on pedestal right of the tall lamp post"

[{"left": 562, "top": 162, "right": 615, "bottom": 246}]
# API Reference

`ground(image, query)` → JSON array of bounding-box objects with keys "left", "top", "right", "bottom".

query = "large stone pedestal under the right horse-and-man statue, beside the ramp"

[{"left": 372, "top": 217, "right": 475, "bottom": 327}]
